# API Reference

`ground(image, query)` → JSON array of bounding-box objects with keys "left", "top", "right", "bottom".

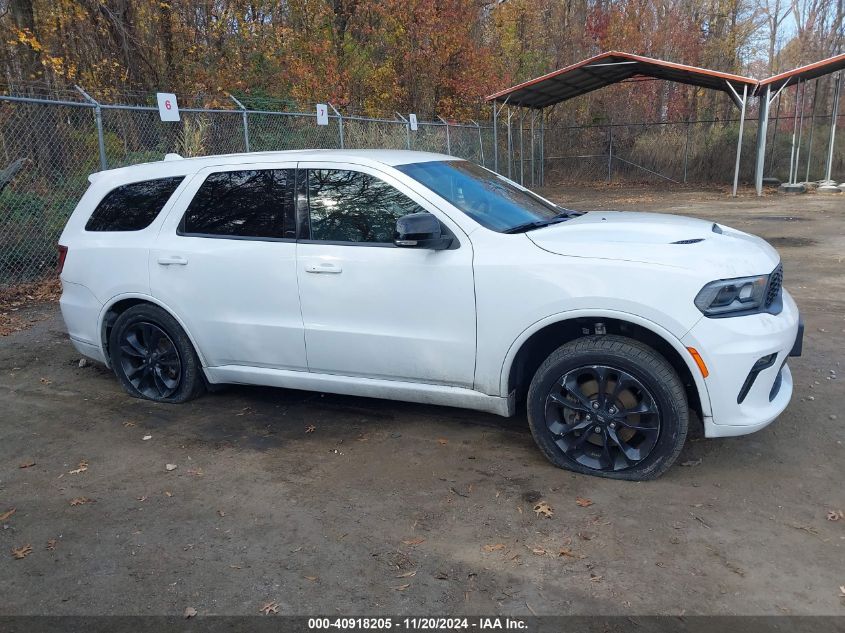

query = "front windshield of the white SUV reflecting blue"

[{"left": 396, "top": 160, "right": 575, "bottom": 233}]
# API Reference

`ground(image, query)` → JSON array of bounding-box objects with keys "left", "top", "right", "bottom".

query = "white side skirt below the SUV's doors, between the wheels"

[{"left": 205, "top": 365, "right": 515, "bottom": 417}]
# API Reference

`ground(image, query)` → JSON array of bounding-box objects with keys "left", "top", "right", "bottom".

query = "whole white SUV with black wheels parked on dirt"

[{"left": 60, "top": 150, "right": 803, "bottom": 479}]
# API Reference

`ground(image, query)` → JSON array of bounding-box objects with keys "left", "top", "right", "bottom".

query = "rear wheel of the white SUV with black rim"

[{"left": 109, "top": 303, "right": 205, "bottom": 404}]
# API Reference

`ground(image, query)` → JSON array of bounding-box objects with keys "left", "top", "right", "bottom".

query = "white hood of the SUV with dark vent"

[{"left": 525, "top": 211, "right": 780, "bottom": 279}]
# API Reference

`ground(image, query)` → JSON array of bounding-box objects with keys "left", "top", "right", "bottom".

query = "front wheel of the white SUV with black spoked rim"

[{"left": 528, "top": 335, "right": 689, "bottom": 481}]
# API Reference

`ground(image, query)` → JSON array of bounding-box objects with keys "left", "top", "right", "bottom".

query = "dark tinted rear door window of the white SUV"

[{"left": 180, "top": 169, "right": 296, "bottom": 238}]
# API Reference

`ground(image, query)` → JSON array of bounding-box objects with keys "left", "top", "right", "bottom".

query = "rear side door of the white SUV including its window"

[{"left": 149, "top": 163, "right": 307, "bottom": 370}]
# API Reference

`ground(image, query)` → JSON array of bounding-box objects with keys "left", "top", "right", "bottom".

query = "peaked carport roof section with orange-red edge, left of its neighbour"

[{"left": 487, "top": 51, "right": 758, "bottom": 108}]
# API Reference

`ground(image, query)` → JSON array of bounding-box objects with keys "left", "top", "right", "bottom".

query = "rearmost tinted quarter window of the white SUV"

[{"left": 85, "top": 176, "right": 183, "bottom": 231}]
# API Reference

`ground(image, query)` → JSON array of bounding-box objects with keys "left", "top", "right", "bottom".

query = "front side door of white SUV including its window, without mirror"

[{"left": 297, "top": 162, "right": 475, "bottom": 387}]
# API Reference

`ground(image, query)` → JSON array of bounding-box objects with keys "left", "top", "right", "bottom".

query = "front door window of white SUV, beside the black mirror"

[{"left": 308, "top": 169, "right": 425, "bottom": 243}]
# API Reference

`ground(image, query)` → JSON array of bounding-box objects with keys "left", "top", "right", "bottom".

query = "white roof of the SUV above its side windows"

[{"left": 89, "top": 149, "right": 452, "bottom": 182}]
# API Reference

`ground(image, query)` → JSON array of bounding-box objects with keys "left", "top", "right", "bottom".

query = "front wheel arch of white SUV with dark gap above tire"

[{"left": 500, "top": 310, "right": 711, "bottom": 421}]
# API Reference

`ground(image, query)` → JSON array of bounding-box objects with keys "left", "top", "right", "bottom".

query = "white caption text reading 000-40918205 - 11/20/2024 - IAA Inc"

[{"left": 308, "top": 617, "right": 528, "bottom": 631}]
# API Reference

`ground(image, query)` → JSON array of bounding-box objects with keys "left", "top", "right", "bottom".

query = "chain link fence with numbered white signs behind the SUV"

[{"left": 0, "top": 91, "right": 492, "bottom": 287}]
